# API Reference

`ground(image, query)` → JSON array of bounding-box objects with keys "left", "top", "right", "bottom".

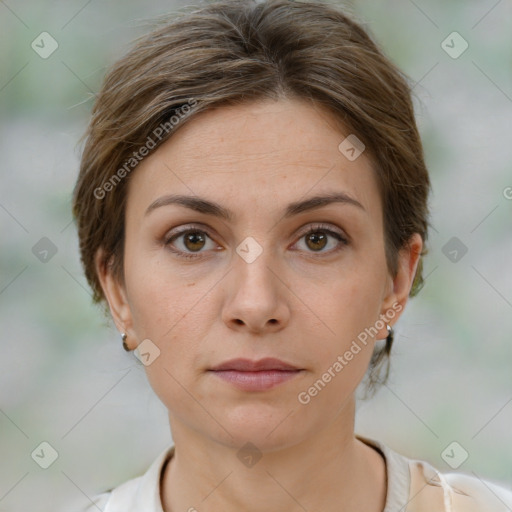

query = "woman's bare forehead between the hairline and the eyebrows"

[{"left": 128, "top": 99, "right": 380, "bottom": 222}]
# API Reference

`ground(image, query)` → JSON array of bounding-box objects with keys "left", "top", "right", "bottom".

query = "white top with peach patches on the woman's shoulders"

[{"left": 84, "top": 435, "right": 512, "bottom": 512}]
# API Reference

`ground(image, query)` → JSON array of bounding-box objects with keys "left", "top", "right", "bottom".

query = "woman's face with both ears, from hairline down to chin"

[{"left": 99, "top": 100, "right": 421, "bottom": 450}]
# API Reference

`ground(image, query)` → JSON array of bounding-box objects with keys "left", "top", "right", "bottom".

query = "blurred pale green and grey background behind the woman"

[{"left": 0, "top": 0, "right": 512, "bottom": 511}]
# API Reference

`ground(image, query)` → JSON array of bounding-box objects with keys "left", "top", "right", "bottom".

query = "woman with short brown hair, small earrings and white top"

[{"left": 74, "top": 0, "right": 512, "bottom": 512}]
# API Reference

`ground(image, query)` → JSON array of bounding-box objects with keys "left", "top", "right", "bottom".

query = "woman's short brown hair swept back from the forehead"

[{"left": 73, "top": 0, "right": 430, "bottom": 394}]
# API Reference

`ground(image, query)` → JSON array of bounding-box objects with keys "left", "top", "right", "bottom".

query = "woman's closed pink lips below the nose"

[{"left": 209, "top": 358, "right": 304, "bottom": 391}]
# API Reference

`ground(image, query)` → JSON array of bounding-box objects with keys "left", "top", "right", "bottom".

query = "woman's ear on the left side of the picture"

[{"left": 94, "top": 248, "right": 135, "bottom": 346}]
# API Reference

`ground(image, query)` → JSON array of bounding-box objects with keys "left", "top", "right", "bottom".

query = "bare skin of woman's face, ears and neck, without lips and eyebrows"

[{"left": 97, "top": 99, "right": 422, "bottom": 512}]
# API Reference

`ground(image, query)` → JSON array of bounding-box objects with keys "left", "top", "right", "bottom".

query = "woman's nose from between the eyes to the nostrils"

[{"left": 222, "top": 251, "right": 290, "bottom": 334}]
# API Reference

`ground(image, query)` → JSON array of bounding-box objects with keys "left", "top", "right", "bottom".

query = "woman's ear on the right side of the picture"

[{"left": 378, "top": 233, "right": 423, "bottom": 339}]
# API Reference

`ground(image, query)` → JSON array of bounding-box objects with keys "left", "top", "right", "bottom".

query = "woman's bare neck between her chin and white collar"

[{"left": 161, "top": 400, "right": 386, "bottom": 512}]
